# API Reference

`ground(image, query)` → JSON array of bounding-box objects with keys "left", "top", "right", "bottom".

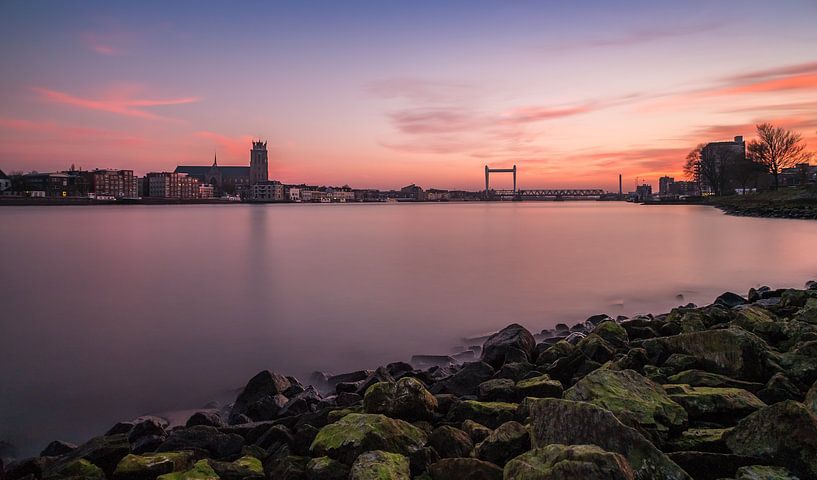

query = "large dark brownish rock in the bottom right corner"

[{"left": 725, "top": 400, "right": 817, "bottom": 478}]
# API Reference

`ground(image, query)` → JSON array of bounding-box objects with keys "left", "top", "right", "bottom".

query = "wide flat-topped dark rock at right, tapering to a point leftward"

[{"left": 642, "top": 327, "right": 775, "bottom": 381}]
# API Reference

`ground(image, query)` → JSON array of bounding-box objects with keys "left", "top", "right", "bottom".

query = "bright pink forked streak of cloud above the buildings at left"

[{"left": 31, "top": 87, "right": 201, "bottom": 120}]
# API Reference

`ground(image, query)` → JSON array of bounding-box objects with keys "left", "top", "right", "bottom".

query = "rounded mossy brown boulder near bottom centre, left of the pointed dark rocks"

[{"left": 363, "top": 377, "right": 437, "bottom": 422}]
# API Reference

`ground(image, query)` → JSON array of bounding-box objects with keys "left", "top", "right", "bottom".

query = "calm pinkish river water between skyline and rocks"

[{"left": 0, "top": 202, "right": 817, "bottom": 452}]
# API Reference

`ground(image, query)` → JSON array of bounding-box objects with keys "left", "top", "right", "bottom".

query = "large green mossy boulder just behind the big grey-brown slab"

[{"left": 564, "top": 369, "right": 687, "bottom": 432}]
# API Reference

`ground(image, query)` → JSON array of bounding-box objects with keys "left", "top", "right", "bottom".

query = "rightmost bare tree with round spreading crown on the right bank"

[{"left": 746, "top": 123, "right": 811, "bottom": 188}]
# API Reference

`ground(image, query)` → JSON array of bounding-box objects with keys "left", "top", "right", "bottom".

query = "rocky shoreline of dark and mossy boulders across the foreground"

[{"left": 0, "top": 282, "right": 817, "bottom": 480}]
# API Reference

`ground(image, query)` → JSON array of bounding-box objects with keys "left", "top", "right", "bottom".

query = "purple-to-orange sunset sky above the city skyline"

[{"left": 0, "top": 0, "right": 817, "bottom": 191}]
